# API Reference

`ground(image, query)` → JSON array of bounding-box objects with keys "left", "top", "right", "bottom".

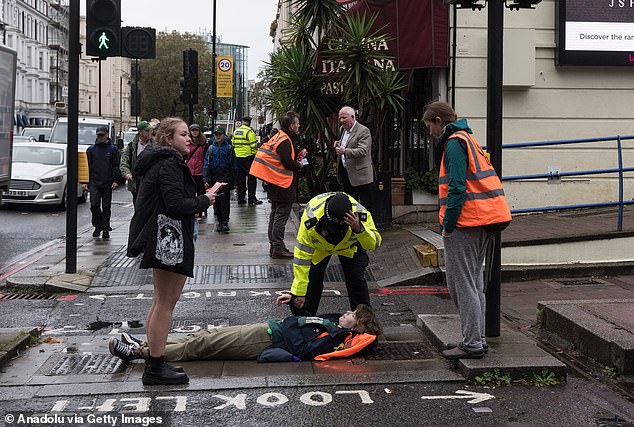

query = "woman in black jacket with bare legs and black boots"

[{"left": 123, "top": 118, "right": 221, "bottom": 385}]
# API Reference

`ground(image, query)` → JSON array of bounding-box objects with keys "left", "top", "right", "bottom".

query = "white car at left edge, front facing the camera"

[{"left": 2, "top": 142, "right": 87, "bottom": 209}]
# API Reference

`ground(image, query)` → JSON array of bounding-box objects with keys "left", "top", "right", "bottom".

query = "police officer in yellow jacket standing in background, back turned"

[{"left": 231, "top": 116, "right": 262, "bottom": 205}]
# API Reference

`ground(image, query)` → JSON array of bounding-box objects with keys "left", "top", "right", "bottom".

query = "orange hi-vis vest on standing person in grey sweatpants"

[{"left": 438, "top": 131, "right": 511, "bottom": 227}]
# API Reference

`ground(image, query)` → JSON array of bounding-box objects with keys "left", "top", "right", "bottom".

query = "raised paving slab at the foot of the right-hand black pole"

[{"left": 417, "top": 314, "right": 566, "bottom": 380}]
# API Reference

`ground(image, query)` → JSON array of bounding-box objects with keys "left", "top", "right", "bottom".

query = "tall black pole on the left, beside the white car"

[{"left": 66, "top": 0, "right": 81, "bottom": 273}]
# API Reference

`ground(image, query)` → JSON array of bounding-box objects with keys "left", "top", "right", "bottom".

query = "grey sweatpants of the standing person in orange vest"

[{"left": 443, "top": 227, "right": 490, "bottom": 351}]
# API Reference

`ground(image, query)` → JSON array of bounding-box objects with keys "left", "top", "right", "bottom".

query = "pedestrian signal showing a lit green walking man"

[{"left": 86, "top": 0, "right": 121, "bottom": 58}]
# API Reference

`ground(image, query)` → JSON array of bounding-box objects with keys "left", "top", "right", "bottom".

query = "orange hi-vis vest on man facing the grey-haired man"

[{"left": 249, "top": 130, "right": 295, "bottom": 188}]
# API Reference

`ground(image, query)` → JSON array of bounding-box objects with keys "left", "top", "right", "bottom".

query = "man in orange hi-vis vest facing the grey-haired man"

[{"left": 249, "top": 111, "right": 306, "bottom": 259}]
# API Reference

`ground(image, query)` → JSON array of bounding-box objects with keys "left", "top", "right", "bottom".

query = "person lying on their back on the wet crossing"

[{"left": 109, "top": 304, "right": 383, "bottom": 362}]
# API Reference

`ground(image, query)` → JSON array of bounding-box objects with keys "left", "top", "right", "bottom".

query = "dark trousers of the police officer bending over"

[{"left": 290, "top": 248, "right": 370, "bottom": 316}]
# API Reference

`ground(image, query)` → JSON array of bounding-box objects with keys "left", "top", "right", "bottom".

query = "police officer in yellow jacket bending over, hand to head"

[{"left": 277, "top": 193, "right": 381, "bottom": 316}]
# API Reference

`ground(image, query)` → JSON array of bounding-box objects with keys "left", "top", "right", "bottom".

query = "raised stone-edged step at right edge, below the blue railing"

[{"left": 538, "top": 299, "right": 634, "bottom": 374}]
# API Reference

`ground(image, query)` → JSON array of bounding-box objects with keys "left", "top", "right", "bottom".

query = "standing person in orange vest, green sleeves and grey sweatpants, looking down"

[{"left": 423, "top": 102, "right": 511, "bottom": 359}]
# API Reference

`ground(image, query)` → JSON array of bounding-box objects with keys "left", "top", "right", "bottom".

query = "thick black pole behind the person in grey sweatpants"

[{"left": 485, "top": 0, "right": 504, "bottom": 337}]
